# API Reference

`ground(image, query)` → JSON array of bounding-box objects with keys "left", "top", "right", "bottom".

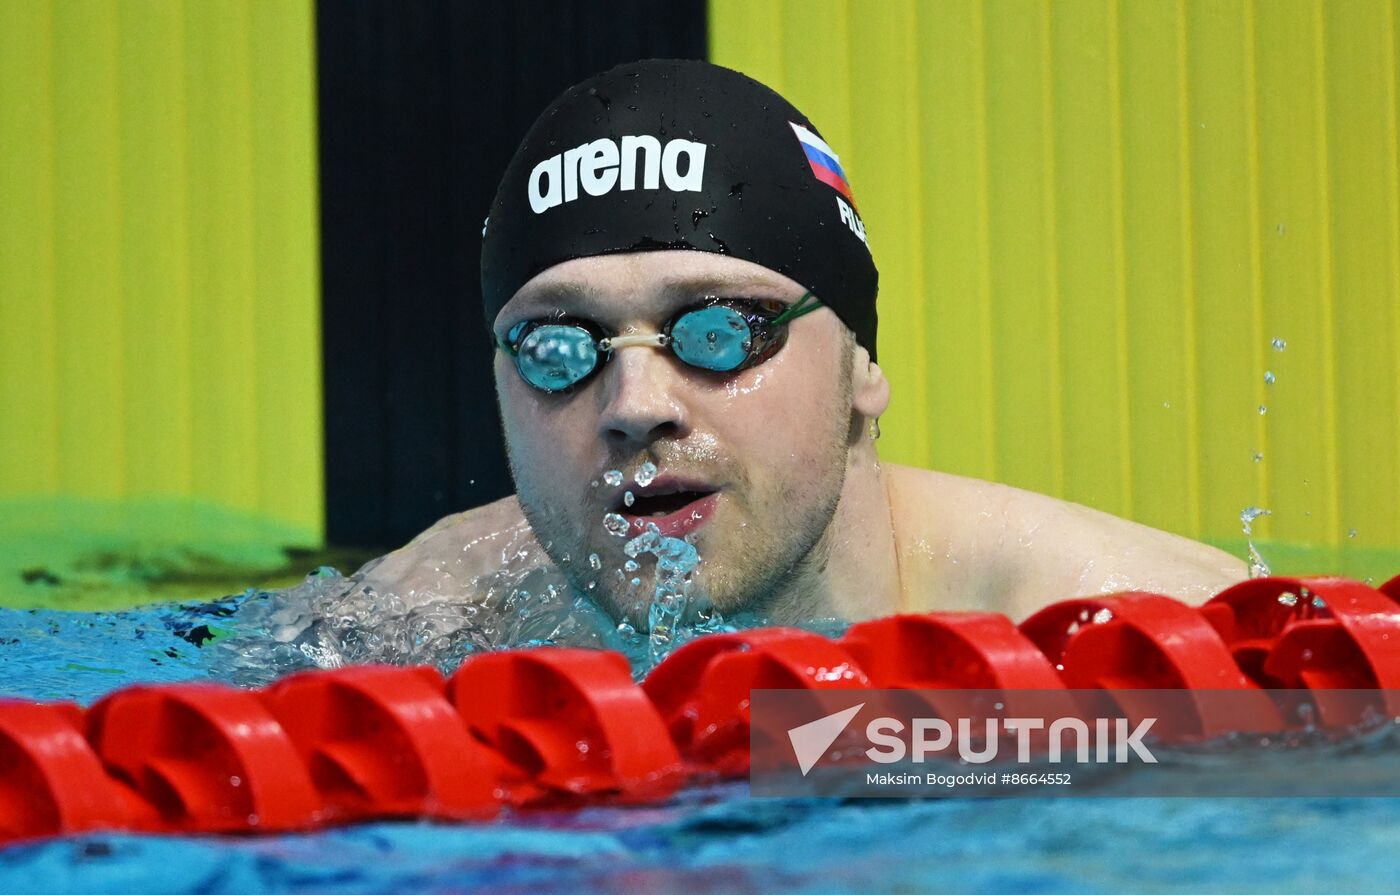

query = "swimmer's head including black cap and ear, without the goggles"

[{"left": 482, "top": 62, "right": 889, "bottom": 622}]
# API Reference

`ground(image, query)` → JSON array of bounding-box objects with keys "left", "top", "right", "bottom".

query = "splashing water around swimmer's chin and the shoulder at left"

[{"left": 190, "top": 473, "right": 847, "bottom": 686}]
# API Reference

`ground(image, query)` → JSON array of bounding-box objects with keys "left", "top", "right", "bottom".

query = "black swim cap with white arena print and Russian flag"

[{"left": 482, "top": 59, "right": 878, "bottom": 360}]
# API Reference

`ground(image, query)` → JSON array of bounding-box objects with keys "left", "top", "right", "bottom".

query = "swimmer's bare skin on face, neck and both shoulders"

[{"left": 367, "top": 251, "right": 1246, "bottom": 622}]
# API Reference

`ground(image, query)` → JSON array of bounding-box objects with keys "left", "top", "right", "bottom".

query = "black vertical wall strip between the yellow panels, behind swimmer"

[{"left": 316, "top": 0, "right": 707, "bottom": 548}]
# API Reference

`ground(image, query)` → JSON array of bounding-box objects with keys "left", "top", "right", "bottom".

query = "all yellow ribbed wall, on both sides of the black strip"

[{"left": 0, "top": 0, "right": 1400, "bottom": 560}]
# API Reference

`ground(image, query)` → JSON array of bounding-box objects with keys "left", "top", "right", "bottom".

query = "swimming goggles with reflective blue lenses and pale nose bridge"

[{"left": 496, "top": 291, "right": 822, "bottom": 392}]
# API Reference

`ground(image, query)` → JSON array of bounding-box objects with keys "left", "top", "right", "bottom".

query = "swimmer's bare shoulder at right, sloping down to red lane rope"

[{"left": 886, "top": 465, "right": 1246, "bottom": 619}]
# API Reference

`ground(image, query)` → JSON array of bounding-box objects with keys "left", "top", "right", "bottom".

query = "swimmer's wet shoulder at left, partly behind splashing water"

[{"left": 352, "top": 496, "right": 550, "bottom": 605}]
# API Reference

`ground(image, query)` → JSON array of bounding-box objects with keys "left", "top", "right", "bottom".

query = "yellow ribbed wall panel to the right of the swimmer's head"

[{"left": 710, "top": 0, "right": 1400, "bottom": 548}]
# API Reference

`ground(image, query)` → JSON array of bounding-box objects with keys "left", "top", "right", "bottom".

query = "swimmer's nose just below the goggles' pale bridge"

[{"left": 598, "top": 346, "right": 690, "bottom": 450}]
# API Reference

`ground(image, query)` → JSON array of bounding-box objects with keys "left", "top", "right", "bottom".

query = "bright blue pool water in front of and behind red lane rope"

[{"left": 0, "top": 599, "right": 1400, "bottom": 895}]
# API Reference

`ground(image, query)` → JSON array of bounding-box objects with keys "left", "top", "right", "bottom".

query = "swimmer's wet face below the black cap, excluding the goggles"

[{"left": 494, "top": 251, "right": 853, "bottom": 623}]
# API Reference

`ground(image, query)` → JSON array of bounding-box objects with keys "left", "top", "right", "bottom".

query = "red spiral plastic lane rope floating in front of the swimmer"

[{"left": 0, "top": 576, "right": 1400, "bottom": 842}]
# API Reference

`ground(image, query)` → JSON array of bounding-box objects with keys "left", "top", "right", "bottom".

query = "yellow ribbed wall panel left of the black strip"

[{"left": 0, "top": 0, "right": 322, "bottom": 539}]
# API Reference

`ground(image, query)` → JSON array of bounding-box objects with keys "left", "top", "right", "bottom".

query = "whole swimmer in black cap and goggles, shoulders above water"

[{"left": 361, "top": 60, "right": 1246, "bottom": 627}]
